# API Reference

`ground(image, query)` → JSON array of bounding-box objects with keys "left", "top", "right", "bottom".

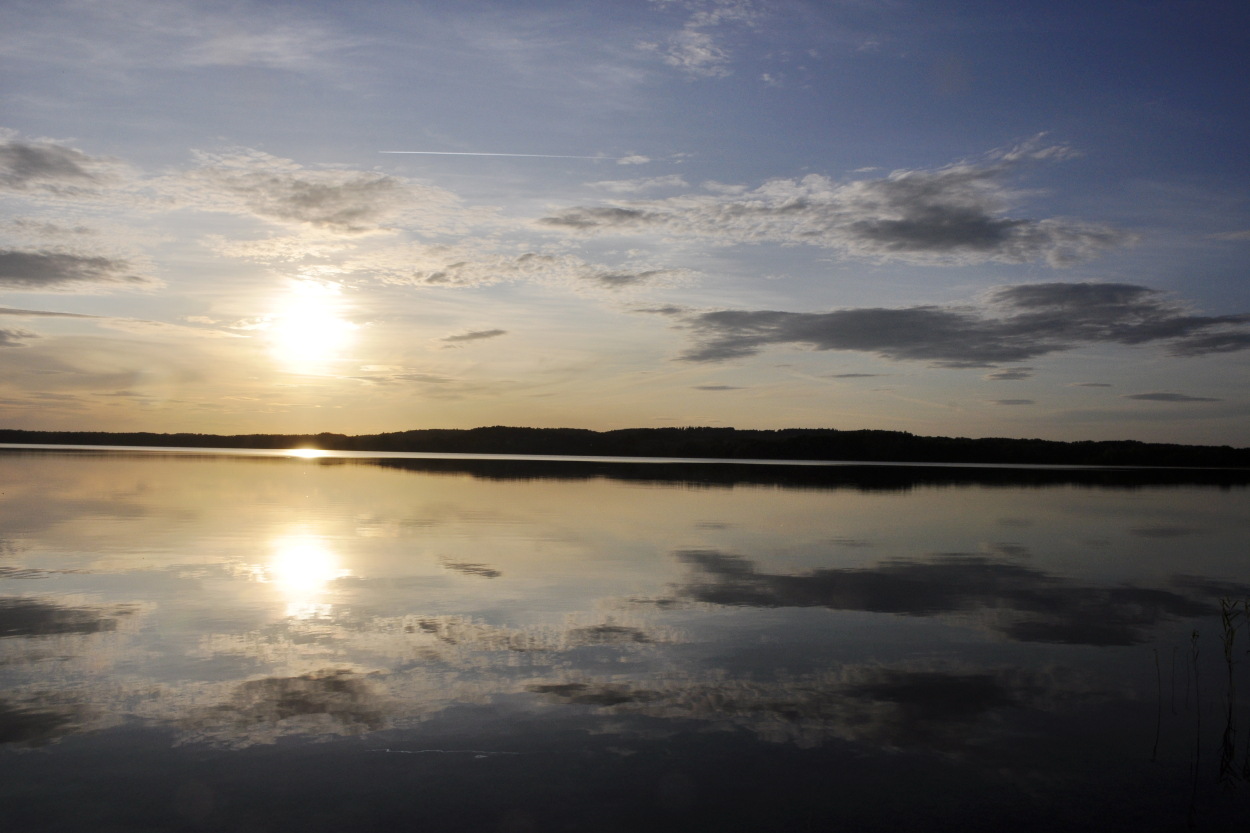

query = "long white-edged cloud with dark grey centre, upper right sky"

[{"left": 538, "top": 148, "right": 1133, "bottom": 266}]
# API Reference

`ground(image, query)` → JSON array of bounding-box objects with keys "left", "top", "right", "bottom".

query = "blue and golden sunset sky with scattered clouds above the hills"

[{"left": 0, "top": 0, "right": 1250, "bottom": 447}]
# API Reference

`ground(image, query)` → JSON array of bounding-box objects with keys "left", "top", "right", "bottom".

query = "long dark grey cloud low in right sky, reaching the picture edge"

[{"left": 678, "top": 283, "right": 1250, "bottom": 362}]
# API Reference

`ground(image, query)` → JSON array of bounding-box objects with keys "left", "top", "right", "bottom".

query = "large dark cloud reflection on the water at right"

[{"left": 678, "top": 550, "right": 1214, "bottom": 645}]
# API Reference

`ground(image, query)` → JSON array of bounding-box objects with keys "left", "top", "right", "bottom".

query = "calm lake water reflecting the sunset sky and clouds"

[{"left": 0, "top": 450, "right": 1250, "bottom": 832}]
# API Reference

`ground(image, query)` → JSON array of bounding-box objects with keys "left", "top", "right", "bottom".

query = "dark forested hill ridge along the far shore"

[{"left": 0, "top": 425, "right": 1250, "bottom": 468}]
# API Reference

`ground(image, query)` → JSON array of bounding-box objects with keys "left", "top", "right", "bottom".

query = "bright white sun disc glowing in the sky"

[{"left": 270, "top": 280, "right": 356, "bottom": 373}]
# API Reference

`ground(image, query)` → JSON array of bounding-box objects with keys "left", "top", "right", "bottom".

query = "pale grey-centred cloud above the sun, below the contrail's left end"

[{"left": 175, "top": 148, "right": 469, "bottom": 235}]
